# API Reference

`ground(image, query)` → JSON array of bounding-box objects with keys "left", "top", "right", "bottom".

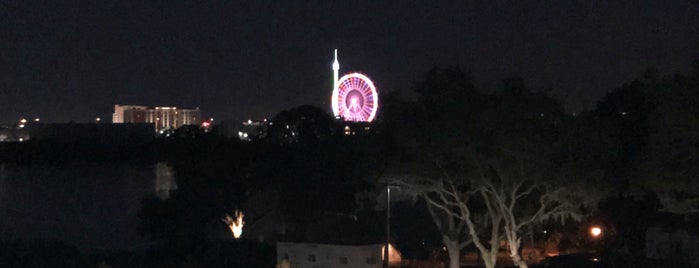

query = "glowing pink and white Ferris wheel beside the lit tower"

[{"left": 332, "top": 73, "right": 379, "bottom": 122}]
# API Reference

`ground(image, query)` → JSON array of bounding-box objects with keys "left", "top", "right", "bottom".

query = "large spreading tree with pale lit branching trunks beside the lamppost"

[{"left": 389, "top": 76, "right": 604, "bottom": 267}]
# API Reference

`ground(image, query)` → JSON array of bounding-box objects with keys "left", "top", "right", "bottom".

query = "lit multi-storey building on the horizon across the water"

[{"left": 112, "top": 104, "right": 201, "bottom": 132}]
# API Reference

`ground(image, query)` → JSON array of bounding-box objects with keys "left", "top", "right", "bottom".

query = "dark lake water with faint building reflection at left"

[{"left": 0, "top": 163, "right": 176, "bottom": 252}]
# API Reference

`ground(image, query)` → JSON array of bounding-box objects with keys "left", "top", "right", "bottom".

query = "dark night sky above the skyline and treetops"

[{"left": 0, "top": 0, "right": 699, "bottom": 123}]
